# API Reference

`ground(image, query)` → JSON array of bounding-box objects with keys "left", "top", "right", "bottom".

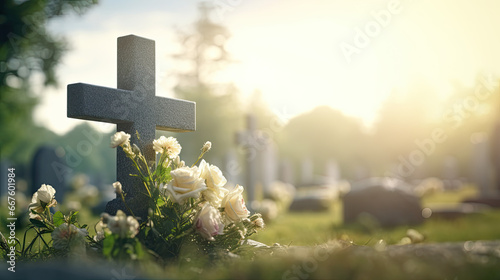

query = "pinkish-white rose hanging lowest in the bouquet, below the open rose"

[{"left": 194, "top": 203, "right": 224, "bottom": 241}]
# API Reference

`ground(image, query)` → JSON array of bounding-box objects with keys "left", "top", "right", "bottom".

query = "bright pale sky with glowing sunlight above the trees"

[{"left": 35, "top": 0, "right": 500, "bottom": 133}]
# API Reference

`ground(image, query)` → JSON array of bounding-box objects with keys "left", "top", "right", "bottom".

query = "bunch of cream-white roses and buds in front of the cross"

[{"left": 109, "top": 132, "right": 263, "bottom": 240}]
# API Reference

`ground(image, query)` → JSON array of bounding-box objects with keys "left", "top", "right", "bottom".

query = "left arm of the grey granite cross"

[{"left": 67, "top": 83, "right": 133, "bottom": 124}]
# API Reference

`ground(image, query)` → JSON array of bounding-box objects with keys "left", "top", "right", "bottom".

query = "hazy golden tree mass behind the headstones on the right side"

[{"left": 278, "top": 76, "right": 500, "bottom": 180}]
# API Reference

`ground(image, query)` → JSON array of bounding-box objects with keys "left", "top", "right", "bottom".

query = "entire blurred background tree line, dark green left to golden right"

[{"left": 0, "top": 0, "right": 500, "bottom": 192}]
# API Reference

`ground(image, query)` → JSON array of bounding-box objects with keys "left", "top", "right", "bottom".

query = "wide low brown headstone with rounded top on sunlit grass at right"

[{"left": 343, "top": 178, "right": 423, "bottom": 226}]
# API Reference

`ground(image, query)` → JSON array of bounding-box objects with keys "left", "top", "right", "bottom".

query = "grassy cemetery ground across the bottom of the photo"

[{"left": 1, "top": 187, "right": 500, "bottom": 279}]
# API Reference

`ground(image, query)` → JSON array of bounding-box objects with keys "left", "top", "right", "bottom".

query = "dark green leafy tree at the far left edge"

[{"left": 0, "top": 0, "right": 97, "bottom": 163}]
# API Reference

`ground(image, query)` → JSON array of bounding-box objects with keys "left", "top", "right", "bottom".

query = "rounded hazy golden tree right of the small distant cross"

[{"left": 279, "top": 106, "right": 373, "bottom": 180}]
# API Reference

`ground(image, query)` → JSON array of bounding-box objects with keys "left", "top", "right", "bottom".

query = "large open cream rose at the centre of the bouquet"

[{"left": 162, "top": 166, "right": 207, "bottom": 204}]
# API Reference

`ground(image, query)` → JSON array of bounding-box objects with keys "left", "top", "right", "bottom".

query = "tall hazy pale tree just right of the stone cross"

[{"left": 167, "top": 3, "right": 243, "bottom": 162}]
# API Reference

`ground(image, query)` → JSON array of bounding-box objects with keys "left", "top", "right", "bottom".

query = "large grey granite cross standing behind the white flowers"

[{"left": 67, "top": 35, "right": 196, "bottom": 217}]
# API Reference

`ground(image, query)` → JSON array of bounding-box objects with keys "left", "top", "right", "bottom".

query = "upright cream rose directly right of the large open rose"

[{"left": 200, "top": 160, "right": 228, "bottom": 207}]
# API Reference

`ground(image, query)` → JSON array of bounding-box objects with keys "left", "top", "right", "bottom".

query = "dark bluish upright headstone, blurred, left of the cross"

[{"left": 27, "top": 146, "right": 67, "bottom": 203}]
